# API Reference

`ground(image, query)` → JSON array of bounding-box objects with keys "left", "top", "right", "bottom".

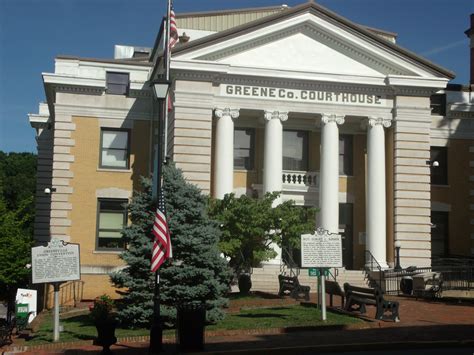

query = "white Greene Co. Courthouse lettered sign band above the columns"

[{"left": 221, "top": 84, "right": 386, "bottom": 106}]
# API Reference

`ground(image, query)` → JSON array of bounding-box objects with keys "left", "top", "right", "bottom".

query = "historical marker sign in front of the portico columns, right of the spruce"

[{"left": 301, "top": 228, "right": 342, "bottom": 268}]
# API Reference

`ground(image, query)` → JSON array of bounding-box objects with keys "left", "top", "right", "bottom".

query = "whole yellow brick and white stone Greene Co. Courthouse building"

[{"left": 30, "top": 2, "right": 474, "bottom": 299}]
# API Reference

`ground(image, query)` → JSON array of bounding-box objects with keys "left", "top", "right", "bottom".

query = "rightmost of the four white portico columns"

[{"left": 366, "top": 117, "right": 391, "bottom": 268}]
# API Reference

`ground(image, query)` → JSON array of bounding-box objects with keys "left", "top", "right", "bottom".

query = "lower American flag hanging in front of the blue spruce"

[{"left": 151, "top": 190, "right": 172, "bottom": 272}]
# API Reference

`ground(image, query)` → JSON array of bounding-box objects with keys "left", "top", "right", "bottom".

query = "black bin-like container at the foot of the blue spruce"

[{"left": 176, "top": 304, "right": 206, "bottom": 351}]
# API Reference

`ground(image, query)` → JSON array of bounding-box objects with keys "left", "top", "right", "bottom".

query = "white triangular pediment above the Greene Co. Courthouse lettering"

[{"left": 172, "top": 4, "right": 454, "bottom": 78}]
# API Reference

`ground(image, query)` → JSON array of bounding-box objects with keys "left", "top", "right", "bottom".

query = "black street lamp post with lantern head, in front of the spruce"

[{"left": 149, "top": 79, "right": 170, "bottom": 354}]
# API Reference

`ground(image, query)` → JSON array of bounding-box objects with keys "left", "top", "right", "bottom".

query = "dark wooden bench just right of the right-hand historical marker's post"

[{"left": 344, "top": 282, "right": 400, "bottom": 322}]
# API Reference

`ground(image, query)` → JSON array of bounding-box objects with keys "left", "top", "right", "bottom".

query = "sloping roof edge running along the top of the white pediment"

[{"left": 172, "top": 1, "right": 456, "bottom": 79}]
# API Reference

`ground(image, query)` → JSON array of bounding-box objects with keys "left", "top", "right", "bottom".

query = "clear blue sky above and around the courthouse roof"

[{"left": 0, "top": 0, "right": 474, "bottom": 152}]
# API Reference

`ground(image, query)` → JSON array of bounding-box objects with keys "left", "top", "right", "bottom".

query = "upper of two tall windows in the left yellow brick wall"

[{"left": 100, "top": 129, "right": 130, "bottom": 169}]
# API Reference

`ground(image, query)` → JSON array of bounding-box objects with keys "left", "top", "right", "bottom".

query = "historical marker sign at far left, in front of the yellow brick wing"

[{"left": 31, "top": 239, "right": 81, "bottom": 284}]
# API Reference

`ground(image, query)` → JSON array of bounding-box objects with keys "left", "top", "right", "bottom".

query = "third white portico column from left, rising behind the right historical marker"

[{"left": 319, "top": 114, "right": 344, "bottom": 233}]
